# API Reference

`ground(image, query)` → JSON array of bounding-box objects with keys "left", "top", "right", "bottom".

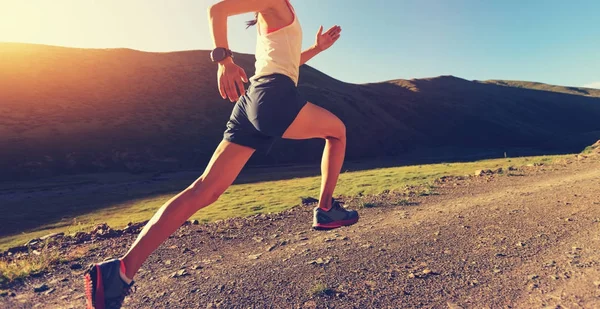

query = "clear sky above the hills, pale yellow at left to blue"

[{"left": 0, "top": 0, "right": 600, "bottom": 88}]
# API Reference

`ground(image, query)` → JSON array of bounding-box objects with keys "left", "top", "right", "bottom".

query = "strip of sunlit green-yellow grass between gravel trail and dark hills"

[{"left": 0, "top": 156, "right": 565, "bottom": 250}]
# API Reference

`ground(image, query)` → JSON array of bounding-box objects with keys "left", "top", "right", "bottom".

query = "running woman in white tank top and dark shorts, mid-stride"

[{"left": 85, "top": 0, "right": 358, "bottom": 309}]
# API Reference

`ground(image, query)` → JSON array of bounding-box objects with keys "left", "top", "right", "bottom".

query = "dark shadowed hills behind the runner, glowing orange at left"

[{"left": 0, "top": 43, "right": 600, "bottom": 180}]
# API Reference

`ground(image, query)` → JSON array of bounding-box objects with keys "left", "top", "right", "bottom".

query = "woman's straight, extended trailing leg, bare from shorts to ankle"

[{"left": 122, "top": 141, "right": 254, "bottom": 278}]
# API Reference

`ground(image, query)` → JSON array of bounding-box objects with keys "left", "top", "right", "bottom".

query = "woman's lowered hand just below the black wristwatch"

[{"left": 217, "top": 58, "right": 248, "bottom": 103}]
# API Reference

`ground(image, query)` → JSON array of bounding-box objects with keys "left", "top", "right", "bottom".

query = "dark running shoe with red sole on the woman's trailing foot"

[{"left": 85, "top": 259, "right": 133, "bottom": 309}]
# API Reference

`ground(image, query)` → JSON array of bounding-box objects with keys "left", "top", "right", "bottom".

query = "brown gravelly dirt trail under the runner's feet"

[{"left": 0, "top": 158, "right": 600, "bottom": 308}]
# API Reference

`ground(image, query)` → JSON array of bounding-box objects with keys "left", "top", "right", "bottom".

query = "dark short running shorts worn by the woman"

[{"left": 224, "top": 74, "right": 307, "bottom": 150}]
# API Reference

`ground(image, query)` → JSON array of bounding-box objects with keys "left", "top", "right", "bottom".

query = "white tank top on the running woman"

[{"left": 252, "top": 0, "right": 302, "bottom": 85}]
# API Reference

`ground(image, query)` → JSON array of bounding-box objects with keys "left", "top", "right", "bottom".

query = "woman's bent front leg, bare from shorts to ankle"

[{"left": 283, "top": 103, "right": 346, "bottom": 210}]
